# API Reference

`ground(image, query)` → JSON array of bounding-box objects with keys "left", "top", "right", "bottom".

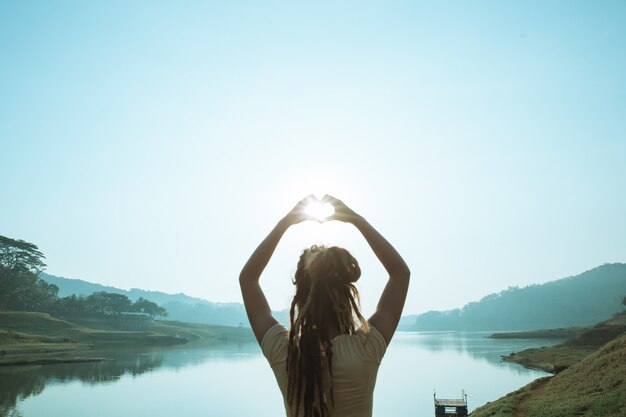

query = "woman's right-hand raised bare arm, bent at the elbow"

[{"left": 323, "top": 196, "right": 411, "bottom": 344}]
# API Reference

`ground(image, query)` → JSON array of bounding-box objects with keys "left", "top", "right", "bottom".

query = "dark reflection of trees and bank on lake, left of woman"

[{"left": 0, "top": 342, "right": 259, "bottom": 417}]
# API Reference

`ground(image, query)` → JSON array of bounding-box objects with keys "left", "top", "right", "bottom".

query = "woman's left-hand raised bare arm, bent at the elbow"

[{"left": 239, "top": 197, "right": 310, "bottom": 344}]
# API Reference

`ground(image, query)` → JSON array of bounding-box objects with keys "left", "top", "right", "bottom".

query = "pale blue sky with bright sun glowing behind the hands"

[{"left": 0, "top": 0, "right": 626, "bottom": 314}]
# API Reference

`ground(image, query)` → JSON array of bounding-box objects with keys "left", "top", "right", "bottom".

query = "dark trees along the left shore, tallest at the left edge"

[{"left": 0, "top": 236, "right": 167, "bottom": 317}]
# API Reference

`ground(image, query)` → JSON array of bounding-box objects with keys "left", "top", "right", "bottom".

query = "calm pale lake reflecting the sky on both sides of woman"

[{"left": 0, "top": 332, "right": 555, "bottom": 417}]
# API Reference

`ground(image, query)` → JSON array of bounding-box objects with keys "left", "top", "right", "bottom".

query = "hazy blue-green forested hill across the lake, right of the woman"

[{"left": 399, "top": 263, "right": 626, "bottom": 331}]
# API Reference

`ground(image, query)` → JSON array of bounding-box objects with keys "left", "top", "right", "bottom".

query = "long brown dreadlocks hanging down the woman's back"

[{"left": 287, "top": 246, "right": 369, "bottom": 417}]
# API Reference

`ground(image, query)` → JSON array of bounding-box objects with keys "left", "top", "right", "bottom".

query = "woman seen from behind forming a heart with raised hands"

[{"left": 239, "top": 195, "right": 410, "bottom": 417}]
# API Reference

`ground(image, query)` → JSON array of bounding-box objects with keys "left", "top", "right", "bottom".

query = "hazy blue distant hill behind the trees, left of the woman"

[{"left": 40, "top": 273, "right": 288, "bottom": 327}]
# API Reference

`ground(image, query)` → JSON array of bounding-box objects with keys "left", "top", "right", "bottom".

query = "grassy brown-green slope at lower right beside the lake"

[{"left": 471, "top": 312, "right": 626, "bottom": 417}]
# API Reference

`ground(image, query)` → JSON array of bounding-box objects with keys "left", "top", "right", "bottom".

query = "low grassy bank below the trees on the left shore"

[{"left": 0, "top": 312, "right": 253, "bottom": 365}]
